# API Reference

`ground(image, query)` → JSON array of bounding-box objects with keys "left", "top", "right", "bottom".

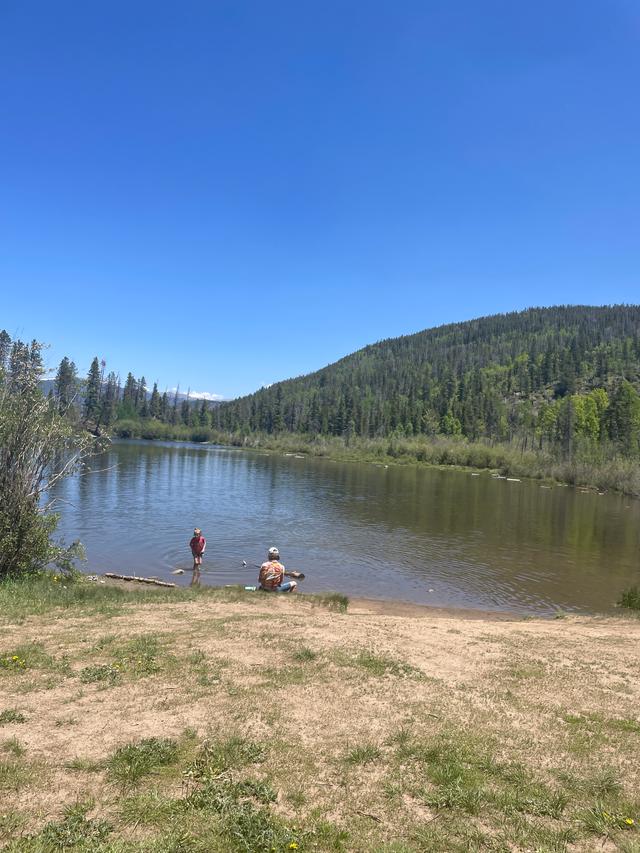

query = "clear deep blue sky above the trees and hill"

[{"left": 0, "top": 0, "right": 640, "bottom": 397}]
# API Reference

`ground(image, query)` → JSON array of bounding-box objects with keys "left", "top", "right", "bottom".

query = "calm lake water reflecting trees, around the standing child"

[{"left": 51, "top": 442, "right": 640, "bottom": 612}]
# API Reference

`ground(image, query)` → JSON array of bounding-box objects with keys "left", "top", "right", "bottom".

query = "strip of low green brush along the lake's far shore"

[{"left": 115, "top": 421, "right": 640, "bottom": 497}]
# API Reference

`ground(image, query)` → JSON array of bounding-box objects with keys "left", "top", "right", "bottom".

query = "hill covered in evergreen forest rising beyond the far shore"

[{"left": 212, "top": 305, "right": 640, "bottom": 453}]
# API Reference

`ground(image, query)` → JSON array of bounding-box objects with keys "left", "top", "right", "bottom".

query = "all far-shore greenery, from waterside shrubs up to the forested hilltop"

[{"left": 5, "top": 305, "right": 640, "bottom": 495}]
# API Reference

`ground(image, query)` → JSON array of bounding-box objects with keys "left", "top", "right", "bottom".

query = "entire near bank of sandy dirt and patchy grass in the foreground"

[{"left": 0, "top": 577, "right": 640, "bottom": 853}]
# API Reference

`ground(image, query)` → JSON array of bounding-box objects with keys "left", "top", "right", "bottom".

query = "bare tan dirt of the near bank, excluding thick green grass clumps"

[{"left": 0, "top": 596, "right": 640, "bottom": 850}]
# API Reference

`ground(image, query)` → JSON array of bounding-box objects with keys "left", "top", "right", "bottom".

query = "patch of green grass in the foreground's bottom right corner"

[{"left": 384, "top": 727, "right": 640, "bottom": 853}]
